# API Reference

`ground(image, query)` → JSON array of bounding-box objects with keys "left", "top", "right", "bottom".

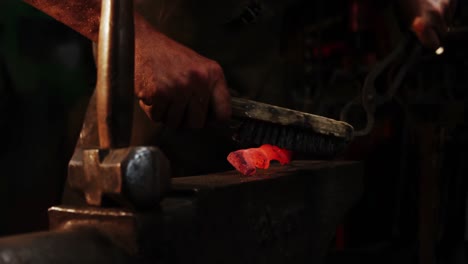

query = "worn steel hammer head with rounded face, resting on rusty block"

[{"left": 68, "top": 147, "right": 171, "bottom": 208}]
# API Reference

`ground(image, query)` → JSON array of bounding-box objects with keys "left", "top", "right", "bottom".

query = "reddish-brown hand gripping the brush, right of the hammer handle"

[{"left": 135, "top": 21, "right": 231, "bottom": 128}]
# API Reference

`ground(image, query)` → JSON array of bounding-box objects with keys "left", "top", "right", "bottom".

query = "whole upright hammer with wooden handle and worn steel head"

[{"left": 68, "top": 0, "right": 170, "bottom": 208}]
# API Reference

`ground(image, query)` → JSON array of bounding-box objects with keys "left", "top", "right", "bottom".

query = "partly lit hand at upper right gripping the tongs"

[{"left": 399, "top": 0, "right": 455, "bottom": 49}]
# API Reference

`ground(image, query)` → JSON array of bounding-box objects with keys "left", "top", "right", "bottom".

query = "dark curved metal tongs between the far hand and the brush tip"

[{"left": 340, "top": 32, "right": 423, "bottom": 136}]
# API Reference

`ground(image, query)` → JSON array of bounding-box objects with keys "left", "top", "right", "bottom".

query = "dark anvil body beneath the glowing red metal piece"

[{"left": 138, "top": 161, "right": 363, "bottom": 264}]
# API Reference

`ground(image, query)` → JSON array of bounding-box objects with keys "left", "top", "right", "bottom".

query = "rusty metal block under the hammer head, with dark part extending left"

[{"left": 0, "top": 207, "right": 137, "bottom": 264}]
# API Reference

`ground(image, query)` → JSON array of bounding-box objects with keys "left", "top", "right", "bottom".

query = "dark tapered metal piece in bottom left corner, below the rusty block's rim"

[{"left": 0, "top": 227, "right": 134, "bottom": 264}]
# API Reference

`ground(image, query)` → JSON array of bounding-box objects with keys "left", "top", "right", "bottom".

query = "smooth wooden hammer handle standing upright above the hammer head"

[{"left": 96, "top": 0, "right": 135, "bottom": 149}]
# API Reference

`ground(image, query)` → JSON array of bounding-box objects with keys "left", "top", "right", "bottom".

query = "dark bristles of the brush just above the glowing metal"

[{"left": 234, "top": 120, "right": 347, "bottom": 159}]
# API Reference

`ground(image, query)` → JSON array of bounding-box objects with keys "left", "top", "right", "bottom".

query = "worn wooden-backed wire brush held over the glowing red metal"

[{"left": 231, "top": 98, "right": 353, "bottom": 159}]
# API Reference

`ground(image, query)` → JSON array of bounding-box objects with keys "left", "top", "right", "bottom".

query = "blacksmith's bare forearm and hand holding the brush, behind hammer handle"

[{"left": 23, "top": 0, "right": 231, "bottom": 128}]
